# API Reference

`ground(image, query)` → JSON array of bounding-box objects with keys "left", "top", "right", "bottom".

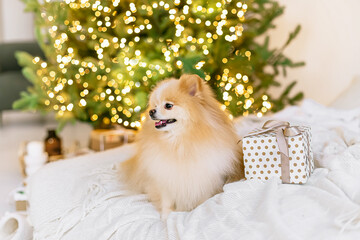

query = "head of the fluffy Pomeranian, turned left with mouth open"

[{"left": 148, "top": 75, "right": 203, "bottom": 131}]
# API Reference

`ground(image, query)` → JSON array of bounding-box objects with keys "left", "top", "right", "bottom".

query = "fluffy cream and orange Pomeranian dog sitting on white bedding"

[{"left": 121, "top": 75, "right": 244, "bottom": 219}]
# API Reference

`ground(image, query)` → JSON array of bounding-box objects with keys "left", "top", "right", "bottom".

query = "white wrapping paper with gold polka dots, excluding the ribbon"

[{"left": 242, "top": 126, "right": 314, "bottom": 184}]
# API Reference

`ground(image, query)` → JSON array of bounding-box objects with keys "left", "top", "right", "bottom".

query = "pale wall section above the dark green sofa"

[{"left": 0, "top": 0, "right": 34, "bottom": 42}]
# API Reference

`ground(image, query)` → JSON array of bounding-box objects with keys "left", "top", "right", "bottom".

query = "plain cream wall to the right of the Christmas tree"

[{"left": 271, "top": 0, "right": 360, "bottom": 104}]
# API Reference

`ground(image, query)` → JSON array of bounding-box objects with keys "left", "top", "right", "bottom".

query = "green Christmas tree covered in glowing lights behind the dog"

[{"left": 14, "top": 0, "right": 303, "bottom": 128}]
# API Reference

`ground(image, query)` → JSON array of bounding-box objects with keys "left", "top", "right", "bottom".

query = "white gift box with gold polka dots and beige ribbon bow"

[{"left": 241, "top": 120, "right": 314, "bottom": 184}]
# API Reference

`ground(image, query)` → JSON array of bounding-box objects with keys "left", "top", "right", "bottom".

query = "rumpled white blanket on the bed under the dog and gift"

[{"left": 28, "top": 100, "right": 360, "bottom": 240}]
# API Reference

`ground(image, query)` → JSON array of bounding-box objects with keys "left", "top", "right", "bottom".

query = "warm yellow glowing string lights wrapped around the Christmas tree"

[{"left": 28, "top": 0, "right": 271, "bottom": 128}]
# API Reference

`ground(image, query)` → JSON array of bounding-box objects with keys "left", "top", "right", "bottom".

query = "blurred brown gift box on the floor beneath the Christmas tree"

[{"left": 90, "top": 128, "right": 136, "bottom": 151}]
